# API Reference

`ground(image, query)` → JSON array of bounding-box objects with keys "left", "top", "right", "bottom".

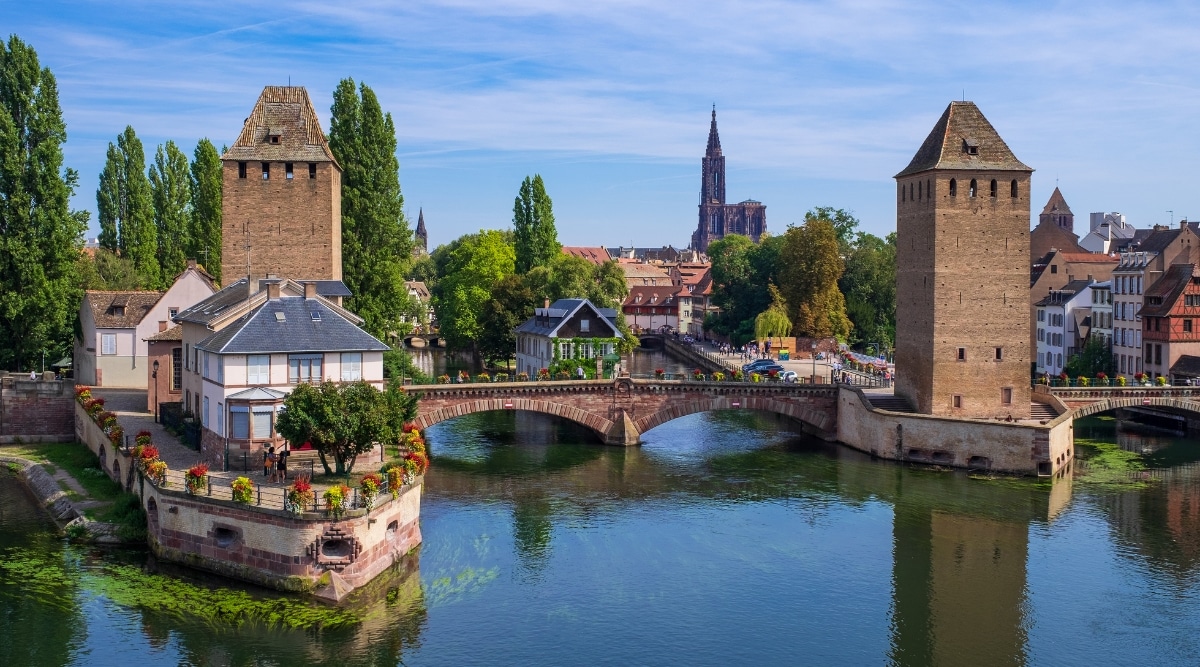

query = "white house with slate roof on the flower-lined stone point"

[{"left": 175, "top": 278, "right": 389, "bottom": 464}]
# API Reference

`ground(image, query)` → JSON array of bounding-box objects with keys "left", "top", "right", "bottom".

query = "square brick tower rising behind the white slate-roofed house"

[{"left": 221, "top": 85, "right": 342, "bottom": 283}]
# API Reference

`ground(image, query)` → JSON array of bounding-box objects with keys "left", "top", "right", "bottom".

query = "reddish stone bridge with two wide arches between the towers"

[{"left": 406, "top": 378, "right": 838, "bottom": 445}]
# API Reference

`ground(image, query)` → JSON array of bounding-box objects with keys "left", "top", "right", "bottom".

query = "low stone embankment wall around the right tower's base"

[{"left": 838, "top": 387, "right": 1074, "bottom": 475}]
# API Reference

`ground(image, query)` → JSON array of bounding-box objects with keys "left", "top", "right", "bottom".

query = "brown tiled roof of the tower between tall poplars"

[{"left": 221, "top": 85, "right": 337, "bottom": 164}]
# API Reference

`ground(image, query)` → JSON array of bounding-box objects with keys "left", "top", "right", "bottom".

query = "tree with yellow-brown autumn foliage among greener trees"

[{"left": 779, "top": 216, "right": 851, "bottom": 339}]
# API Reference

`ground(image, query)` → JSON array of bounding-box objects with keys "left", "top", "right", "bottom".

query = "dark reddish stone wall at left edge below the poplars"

[{"left": 0, "top": 373, "right": 76, "bottom": 443}]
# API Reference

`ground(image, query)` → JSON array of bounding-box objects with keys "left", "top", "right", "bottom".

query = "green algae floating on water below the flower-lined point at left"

[{"left": 0, "top": 549, "right": 362, "bottom": 630}]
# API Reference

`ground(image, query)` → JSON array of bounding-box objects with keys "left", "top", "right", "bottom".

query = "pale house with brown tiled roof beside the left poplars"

[{"left": 74, "top": 260, "right": 216, "bottom": 389}]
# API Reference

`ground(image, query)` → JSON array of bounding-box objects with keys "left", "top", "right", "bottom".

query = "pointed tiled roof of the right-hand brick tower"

[{"left": 895, "top": 102, "right": 1033, "bottom": 178}]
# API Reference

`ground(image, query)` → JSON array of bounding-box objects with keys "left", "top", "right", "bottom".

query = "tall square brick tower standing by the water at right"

[{"left": 895, "top": 102, "right": 1033, "bottom": 419}]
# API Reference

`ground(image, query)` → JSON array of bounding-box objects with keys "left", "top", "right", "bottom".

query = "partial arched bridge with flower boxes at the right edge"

[{"left": 1034, "top": 386, "right": 1200, "bottom": 419}]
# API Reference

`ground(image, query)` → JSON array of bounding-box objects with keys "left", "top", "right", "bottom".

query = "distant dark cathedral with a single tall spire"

[{"left": 691, "top": 107, "right": 767, "bottom": 252}]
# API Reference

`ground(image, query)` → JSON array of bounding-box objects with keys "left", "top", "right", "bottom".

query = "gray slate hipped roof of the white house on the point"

[{"left": 196, "top": 296, "right": 390, "bottom": 354}]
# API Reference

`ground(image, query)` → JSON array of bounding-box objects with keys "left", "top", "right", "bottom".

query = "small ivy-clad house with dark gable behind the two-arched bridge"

[{"left": 516, "top": 299, "right": 624, "bottom": 377}]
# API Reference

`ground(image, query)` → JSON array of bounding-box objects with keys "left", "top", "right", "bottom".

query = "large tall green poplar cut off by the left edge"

[{"left": 0, "top": 35, "right": 88, "bottom": 371}]
